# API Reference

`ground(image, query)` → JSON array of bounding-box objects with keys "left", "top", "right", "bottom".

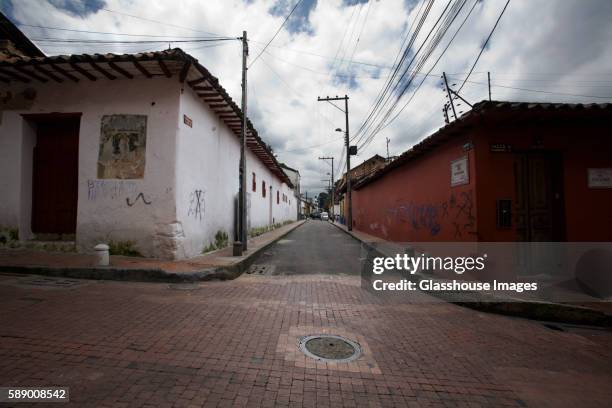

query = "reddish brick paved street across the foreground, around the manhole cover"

[{"left": 0, "top": 221, "right": 612, "bottom": 408}]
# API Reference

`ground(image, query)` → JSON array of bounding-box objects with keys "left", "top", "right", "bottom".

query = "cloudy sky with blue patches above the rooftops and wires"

[{"left": 0, "top": 0, "right": 612, "bottom": 196}]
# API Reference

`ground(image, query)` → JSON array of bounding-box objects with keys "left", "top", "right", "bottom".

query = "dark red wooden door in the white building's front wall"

[{"left": 32, "top": 117, "right": 80, "bottom": 234}]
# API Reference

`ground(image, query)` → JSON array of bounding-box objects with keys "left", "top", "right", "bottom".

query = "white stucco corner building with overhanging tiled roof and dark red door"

[{"left": 0, "top": 49, "right": 298, "bottom": 259}]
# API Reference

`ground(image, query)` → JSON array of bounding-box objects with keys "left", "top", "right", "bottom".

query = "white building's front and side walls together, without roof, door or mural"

[{"left": 0, "top": 78, "right": 297, "bottom": 259}]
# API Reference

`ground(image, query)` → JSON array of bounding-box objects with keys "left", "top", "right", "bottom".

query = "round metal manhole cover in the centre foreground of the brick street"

[{"left": 299, "top": 334, "right": 361, "bottom": 363}]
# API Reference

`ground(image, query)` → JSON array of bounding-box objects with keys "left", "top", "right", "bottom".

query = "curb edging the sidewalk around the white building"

[{"left": 0, "top": 220, "right": 306, "bottom": 283}]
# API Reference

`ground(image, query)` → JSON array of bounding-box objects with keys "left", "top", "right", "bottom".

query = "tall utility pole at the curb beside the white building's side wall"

[{"left": 234, "top": 31, "right": 249, "bottom": 256}]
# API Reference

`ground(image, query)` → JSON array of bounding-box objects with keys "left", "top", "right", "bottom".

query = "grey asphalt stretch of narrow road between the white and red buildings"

[{"left": 255, "top": 220, "right": 361, "bottom": 275}]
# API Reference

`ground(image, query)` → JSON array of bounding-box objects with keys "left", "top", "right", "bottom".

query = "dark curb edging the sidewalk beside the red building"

[{"left": 332, "top": 223, "right": 612, "bottom": 327}]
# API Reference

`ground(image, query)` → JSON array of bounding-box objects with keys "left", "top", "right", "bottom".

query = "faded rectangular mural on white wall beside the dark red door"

[{"left": 98, "top": 115, "right": 147, "bottom": 179}]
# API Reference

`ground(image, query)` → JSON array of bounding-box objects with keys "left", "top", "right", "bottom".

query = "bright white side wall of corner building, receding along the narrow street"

[{"left": 177, "top": 87, "right": 297, "bottom": 257}]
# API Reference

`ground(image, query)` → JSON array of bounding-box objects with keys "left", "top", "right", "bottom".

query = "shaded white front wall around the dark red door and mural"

[{"left": 0, "top": 78, "right": 181, "bottom": 257}]
